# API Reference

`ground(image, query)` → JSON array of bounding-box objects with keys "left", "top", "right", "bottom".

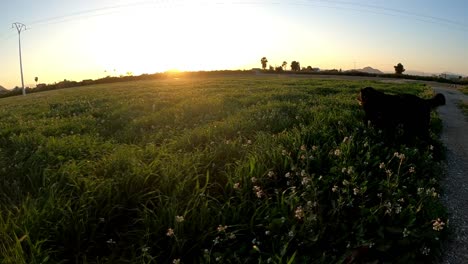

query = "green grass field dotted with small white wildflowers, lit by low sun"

[{"left": 0, "top": 77, "right": 448, "bottom": 263}]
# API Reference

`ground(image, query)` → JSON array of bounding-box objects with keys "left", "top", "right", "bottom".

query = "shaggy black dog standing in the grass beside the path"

[{"left": 358, "top": 87, "right": 445, "bottom": 140}]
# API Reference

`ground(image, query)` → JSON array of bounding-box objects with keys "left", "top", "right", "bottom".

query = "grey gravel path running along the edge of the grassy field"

[{"left": 432, "top": 84, "right": 468, "bottom": 264}]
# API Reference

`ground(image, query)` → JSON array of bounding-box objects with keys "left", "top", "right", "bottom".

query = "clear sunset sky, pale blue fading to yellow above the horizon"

[{"left": 0, "top": 0, "right": 468, "bottom": 88}]
